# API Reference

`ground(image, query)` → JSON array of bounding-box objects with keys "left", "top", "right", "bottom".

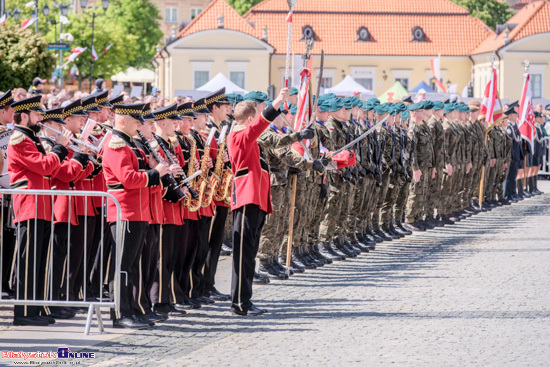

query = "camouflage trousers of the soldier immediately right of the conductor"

[{"left": 258, "top": 186, "right": 289, "bottom": 259}]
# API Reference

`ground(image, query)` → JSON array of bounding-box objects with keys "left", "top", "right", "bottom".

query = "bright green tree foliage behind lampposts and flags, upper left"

[{"left": 2, "top": 0, "right": 163, "bottom": 80}]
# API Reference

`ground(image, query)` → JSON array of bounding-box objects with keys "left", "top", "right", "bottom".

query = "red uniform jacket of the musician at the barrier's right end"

[{"left": 103, "top": 129, "right": 160, "bottom": 222}]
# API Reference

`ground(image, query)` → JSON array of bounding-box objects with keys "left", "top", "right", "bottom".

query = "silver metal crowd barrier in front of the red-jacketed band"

[{"left": 0, "top": 189, "right": 124, "bottom": 335}]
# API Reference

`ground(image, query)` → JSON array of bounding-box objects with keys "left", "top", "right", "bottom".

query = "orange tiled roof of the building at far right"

[{"left": 472, "top": 0, "right": 550, "bottom": 54}]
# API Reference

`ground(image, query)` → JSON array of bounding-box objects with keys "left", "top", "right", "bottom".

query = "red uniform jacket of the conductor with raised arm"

[{"left": 227, "top": 105, "right": 280, "bottom": 214}]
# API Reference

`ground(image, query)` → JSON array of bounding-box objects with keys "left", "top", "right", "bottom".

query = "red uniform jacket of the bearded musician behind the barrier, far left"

[{"left": 7, "top": 125, "right": 68, "bottom": 223}]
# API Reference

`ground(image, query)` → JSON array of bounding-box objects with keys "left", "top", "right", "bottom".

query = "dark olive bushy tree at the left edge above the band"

[{"left": 0, "top": 25, "right": 56, "bottom": 91}]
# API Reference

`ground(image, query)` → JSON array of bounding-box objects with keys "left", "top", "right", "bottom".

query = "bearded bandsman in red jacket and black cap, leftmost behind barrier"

[{"left": 8, "top": 96, "right": 69, "bottom": 326}]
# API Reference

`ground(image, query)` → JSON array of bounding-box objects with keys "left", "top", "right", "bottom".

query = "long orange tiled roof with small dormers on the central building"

[{"left": 179, "top": 0, "right": 494, "bottom": 56}]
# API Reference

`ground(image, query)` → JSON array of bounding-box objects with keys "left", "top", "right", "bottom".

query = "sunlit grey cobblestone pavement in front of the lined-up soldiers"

[{"left": 4, "top": 185, "right": 550, "bottom": 366}]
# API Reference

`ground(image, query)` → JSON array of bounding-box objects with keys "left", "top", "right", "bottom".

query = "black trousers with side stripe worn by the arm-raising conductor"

[{"left": 231, "top": 204, "right": 266, "bottom": 311}]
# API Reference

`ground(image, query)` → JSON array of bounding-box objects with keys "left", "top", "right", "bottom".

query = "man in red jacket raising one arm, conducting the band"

[{"left": 227, "top": 88, "right": 289, "bottom": 316}]
